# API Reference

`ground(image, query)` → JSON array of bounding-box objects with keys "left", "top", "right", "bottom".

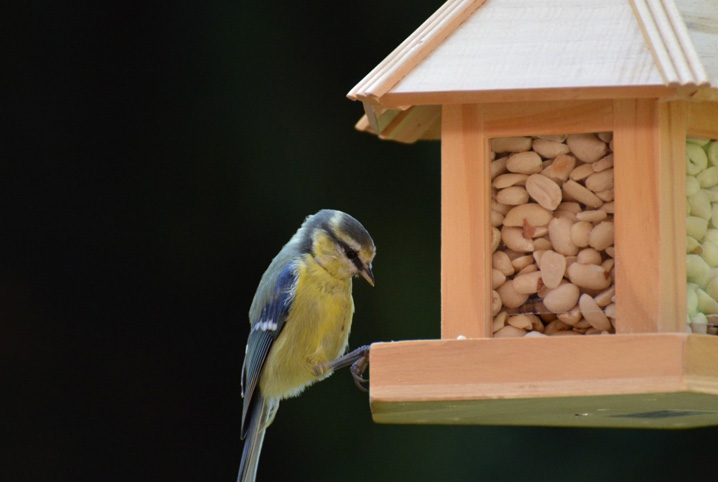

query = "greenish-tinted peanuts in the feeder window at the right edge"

[{"left": 686, "top": 139, "right": 718, "bottom": 335}]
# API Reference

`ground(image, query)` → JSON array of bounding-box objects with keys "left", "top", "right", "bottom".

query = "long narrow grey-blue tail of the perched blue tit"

[{"left": 237, "top": 393, "right": 279, "bottom": 482}]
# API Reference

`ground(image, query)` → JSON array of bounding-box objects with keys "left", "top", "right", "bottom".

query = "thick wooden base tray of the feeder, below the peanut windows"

[{"left": 370, "top": 334, "right": 718, "bottom": 428}]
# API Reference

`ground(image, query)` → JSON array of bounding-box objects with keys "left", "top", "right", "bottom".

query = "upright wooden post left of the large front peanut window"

[{"left": 441, "top": 104, "right": 491, "bottom": 339}]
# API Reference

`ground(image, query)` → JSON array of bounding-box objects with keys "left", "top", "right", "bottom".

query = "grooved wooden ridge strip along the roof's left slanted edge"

[{"left": 347, "top": 0, "right": 486, "bottom": 103}]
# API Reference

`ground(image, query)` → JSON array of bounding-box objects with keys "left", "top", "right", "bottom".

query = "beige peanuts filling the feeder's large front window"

[{"left": 490, "top": 133, "right": 620, "bottom": 337}]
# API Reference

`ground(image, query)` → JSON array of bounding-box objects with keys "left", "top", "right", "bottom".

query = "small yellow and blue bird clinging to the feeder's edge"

[{"left": 237, "top": 209, "right": 376, "bottom": 482}]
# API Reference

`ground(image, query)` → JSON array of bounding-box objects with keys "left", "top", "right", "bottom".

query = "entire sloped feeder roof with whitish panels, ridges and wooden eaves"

[{"left": 348, "top": 0, "right": 718, "bottom": 142}]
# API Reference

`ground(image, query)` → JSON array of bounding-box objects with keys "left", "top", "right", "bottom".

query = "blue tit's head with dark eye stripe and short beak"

[{"left": 302, "top": 209, "right": 376, "bottom": 286}]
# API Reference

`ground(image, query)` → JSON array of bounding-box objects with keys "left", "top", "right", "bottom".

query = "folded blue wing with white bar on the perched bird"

[{"left": 242, "top": 263, "right": 297, "bottom": 438}]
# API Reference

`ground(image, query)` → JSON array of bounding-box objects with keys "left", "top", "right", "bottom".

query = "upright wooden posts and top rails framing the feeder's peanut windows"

[{"left": 441, "top": 99, "right": 704, "bottom": 339}]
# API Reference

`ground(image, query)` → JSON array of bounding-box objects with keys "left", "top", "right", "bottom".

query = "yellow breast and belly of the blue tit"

[{"left": 260, "top": 256, "right": 354, "bottom": 398}]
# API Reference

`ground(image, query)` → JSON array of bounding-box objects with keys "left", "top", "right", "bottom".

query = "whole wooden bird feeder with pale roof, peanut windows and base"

[{"left": 348, "top": 0, "right": 718, "bottom": 428}]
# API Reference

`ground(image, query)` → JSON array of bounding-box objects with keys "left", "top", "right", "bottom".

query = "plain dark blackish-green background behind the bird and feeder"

[{"left": 5, "top": 0, "right": 718, "bottom": 482}]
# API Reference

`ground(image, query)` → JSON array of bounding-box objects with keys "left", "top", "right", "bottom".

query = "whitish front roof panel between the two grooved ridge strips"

[{"left": 391, "top": 0, "right": 664, "bottom": 94}]
